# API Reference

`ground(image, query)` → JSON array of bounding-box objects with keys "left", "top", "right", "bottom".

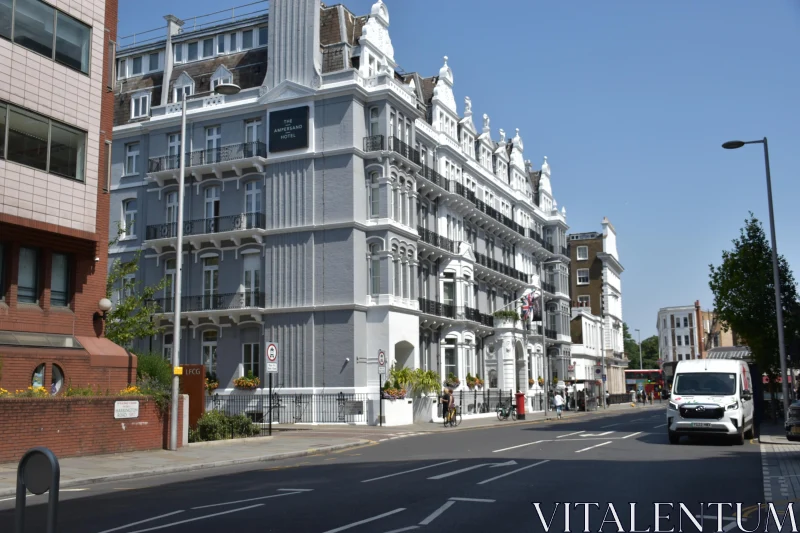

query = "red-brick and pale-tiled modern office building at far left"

[{"left": 0, "top": 0, "right": 130, "bottom": 386}]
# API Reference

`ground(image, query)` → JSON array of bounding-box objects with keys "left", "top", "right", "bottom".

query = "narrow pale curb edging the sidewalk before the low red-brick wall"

[{"left": 0, "top": 439, "right": 371, "bottom": 497}]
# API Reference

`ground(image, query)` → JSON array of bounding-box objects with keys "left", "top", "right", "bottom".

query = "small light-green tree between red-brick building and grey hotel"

[{"left": 105, "top": 227, "right": 168, "bottom": 347}]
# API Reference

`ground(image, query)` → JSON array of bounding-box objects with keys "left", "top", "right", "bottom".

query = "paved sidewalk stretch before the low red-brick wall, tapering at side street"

[{"left": 0, "top": 435, "right": 370, "bottom": 497}]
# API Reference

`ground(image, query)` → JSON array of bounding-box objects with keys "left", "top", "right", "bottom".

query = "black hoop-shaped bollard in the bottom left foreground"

[{"left": 15, "top": 448, "right": 61, "bottom": 533}]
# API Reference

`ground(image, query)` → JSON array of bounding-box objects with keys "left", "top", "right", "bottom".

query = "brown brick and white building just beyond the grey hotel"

[{"left": 568, "top": 218, "right": 629, "bottom": 393}]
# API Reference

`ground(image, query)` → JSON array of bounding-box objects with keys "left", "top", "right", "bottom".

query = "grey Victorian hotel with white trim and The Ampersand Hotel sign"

[{"left": 111, "top": 0, "right": 570, "bottom": 408}]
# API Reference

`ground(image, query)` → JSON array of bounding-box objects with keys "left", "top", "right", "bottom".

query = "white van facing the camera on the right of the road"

[{"left": 667, "top": 359, "right": 753, "bottom": 444}]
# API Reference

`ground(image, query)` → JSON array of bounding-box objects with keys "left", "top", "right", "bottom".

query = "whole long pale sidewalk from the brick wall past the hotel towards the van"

[{"left": 0, "top": 403, "right": 664, "bottom": 497}]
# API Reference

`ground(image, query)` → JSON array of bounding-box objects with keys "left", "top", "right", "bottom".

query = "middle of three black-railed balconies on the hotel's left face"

[{"left": 145, "top": 213, "right": 267, "bottom": 253}]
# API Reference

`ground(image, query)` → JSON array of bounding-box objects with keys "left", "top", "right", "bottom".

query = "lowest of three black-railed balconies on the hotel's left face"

[{"left": 153, "top": 291, "right": 266, "bottom": 324}]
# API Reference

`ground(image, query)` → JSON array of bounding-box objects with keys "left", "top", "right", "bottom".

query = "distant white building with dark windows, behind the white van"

[{"left": 656, "top": 301, "right": 706, "bottom": 363}]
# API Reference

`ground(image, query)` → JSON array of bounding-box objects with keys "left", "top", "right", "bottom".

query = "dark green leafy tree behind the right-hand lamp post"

[{"left": 709, "top": 213, "right": 800, "bottom": 377}]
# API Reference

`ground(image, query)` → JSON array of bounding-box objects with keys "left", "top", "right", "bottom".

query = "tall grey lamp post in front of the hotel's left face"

[{"left": 169, "top": 83, "right": 241, "bottom": 451}]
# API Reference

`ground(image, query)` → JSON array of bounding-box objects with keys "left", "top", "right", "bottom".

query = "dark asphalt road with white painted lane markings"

[{"left": 0, "top": 409, "right": 763, "bottom": 533}]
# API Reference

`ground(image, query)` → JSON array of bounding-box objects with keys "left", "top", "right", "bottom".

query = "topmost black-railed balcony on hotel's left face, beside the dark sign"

[{"left": 147, "top": 141, "right": 267, "bottom": 186}]
